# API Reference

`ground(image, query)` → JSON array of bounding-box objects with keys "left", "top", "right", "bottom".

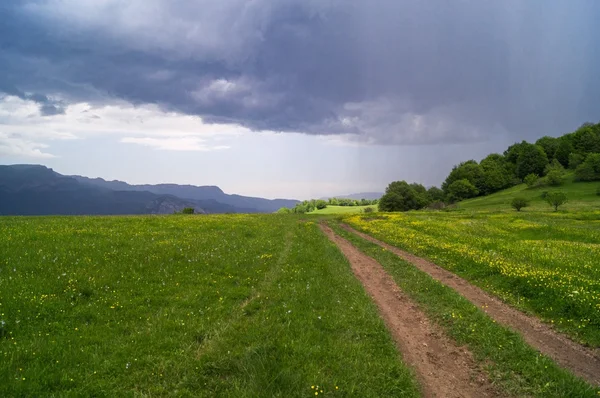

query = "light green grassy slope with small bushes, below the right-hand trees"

[{"left": 458, "top": 176, "right": 600, "bottom": 211}]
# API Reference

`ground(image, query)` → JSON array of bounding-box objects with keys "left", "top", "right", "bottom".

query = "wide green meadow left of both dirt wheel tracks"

[{"left": 0, "top": 215, "right": 419, "bottom": 397}]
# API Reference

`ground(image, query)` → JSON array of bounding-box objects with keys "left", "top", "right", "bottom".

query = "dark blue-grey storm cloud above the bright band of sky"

[{"left": 0, "top": 0, "right": 600, "bottom": 143}]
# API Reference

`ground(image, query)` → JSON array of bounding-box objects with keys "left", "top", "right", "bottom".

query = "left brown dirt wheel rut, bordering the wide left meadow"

[{"left": 320, "top": 224, "right": 498, "bottom": 398}]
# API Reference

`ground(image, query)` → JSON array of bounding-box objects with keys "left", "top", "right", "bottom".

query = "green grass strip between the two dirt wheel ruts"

[{"left": 329, "top": 222, "right": 600, "bottom": 397}]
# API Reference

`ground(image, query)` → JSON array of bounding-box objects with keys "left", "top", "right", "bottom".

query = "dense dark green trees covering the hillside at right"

[{"left": 379, "top": 123, "right": 600, "bottom": 211}]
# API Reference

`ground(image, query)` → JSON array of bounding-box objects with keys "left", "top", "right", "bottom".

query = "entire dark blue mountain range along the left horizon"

[{"left": 0, "top": 165, "right": 296, "bottom": 215}]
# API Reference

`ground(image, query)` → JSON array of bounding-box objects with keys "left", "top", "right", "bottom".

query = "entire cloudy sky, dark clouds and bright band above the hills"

[{"left": 0, "top": 0, "right": 600, "bottom": 199}]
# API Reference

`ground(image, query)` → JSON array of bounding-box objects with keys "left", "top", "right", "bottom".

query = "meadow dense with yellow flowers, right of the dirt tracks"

[{"left": 344, "top": 212, "right": 600, "bottom": 347}]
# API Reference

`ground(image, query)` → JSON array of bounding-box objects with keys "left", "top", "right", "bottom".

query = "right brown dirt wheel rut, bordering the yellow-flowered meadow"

[{"left": 341, "top": 224, "right": 600, "bottom": 385}]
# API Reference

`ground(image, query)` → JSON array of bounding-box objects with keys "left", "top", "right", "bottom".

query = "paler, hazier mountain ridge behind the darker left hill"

[{"left": 72, "top": 176, "right": 299, "bottom": 213}]
